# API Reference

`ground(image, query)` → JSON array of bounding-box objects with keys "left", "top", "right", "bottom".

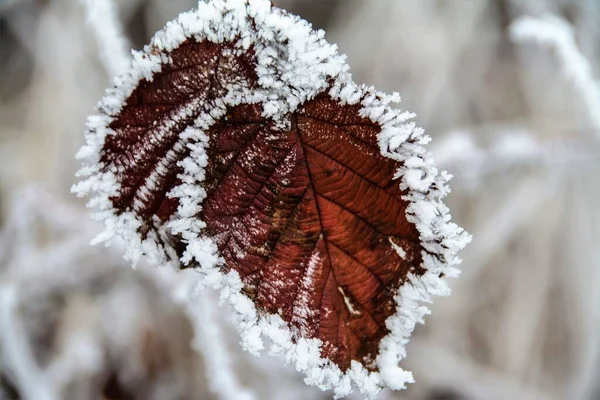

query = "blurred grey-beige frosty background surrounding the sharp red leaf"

[{"left": 0, "top": 0, "right": 600, "bottom": 400}]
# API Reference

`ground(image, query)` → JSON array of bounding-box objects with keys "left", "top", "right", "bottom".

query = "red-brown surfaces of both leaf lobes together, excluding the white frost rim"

[{"left": 102, "top": 40, "right": 423, "bottom": 371}]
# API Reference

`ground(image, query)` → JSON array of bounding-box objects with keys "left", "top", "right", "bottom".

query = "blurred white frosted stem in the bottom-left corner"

[{"left": 0, "top": 285, "right": 57, "bottom": 400}]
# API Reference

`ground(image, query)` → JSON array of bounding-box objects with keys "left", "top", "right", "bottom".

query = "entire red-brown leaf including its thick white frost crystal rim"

[{"left": 75, "top": 0, "right": 469, "bottom": 397}]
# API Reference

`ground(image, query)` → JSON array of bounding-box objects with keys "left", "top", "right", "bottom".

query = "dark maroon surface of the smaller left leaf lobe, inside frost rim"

[{"left": 101, "top": 40, "right": 256, "bottom": 234}]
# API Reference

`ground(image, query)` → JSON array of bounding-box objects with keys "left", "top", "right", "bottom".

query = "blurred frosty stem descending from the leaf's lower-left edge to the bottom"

[{"left": 188, "top": 292, "right": 255, "bottom": 400}]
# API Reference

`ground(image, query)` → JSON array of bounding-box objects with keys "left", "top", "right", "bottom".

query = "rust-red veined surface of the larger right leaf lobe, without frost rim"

[{"left": 202, "top": 94, "right": 421, "bottom": 370}]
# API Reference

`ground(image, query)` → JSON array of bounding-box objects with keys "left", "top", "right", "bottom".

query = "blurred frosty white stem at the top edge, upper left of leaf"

[{"left": 81, "top": 0, "right": 131, "bottom": 76}]
